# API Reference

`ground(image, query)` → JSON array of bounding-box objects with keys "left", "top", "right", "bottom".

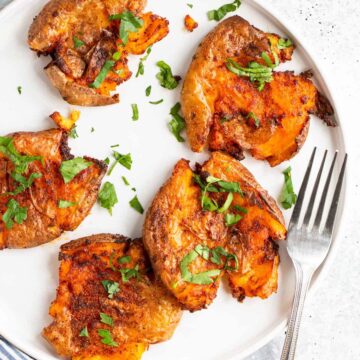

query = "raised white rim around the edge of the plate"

[{"left": 0, "top": 0, "right": 350, "bottom": 360}]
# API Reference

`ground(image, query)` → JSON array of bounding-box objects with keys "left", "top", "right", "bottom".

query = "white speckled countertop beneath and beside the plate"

[{"left": 0, "top": 0, "right": 360, "bottom": 360}]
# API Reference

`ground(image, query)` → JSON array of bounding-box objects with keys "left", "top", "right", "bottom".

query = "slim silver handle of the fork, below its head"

[{"left": 281, "top": 261, "right": 314, "bottom": 360}]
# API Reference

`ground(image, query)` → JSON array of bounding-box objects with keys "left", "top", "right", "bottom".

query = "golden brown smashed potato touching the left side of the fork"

[{"left": 143, "top": 152, "right": 286, "bottom": 311}]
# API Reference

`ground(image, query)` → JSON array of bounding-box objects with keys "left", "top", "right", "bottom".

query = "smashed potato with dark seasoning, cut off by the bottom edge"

[{"left": 43, "top": 234, "right": 181, "bottom": 360}]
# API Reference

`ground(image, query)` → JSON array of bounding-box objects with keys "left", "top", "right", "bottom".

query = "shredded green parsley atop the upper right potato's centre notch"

[{"left": 226, "top": 59, "right": 273, "bottom": 91}]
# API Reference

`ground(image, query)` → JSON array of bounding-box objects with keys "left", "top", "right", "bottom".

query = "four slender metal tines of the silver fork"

[{"left": 289, "top": 148, "right": 347, "bottom": 236}]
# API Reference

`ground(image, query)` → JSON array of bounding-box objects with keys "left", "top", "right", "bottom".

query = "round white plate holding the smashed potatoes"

[{"left": 0, "top": 0, "right": 345, "bottom": 360}]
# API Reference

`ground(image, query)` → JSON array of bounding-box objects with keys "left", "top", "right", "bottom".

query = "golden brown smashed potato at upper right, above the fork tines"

[{"left": 182, "top": 16, "right": 335, "bottom": 166}]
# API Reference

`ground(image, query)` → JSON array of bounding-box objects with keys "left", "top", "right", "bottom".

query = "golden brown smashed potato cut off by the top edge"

[{"left": 28, "top": 0, "right": 169, "bottom": 106}]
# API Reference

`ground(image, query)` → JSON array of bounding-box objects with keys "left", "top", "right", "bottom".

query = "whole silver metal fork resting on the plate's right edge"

[{"left": 281, "top": 148, "right": 347, "bottom": 360}]
